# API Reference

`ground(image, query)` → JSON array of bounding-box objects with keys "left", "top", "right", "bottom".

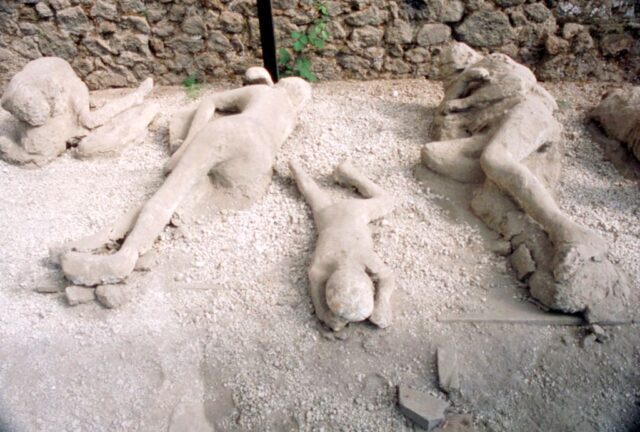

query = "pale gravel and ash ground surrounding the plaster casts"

[{"left": 0, "top": 80, "right": 640, "bottom": 432}]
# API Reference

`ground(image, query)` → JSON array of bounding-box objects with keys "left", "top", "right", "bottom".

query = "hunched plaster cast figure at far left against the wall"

[{"left": 0, "top": 57, "right": 158, "bottom": 166}]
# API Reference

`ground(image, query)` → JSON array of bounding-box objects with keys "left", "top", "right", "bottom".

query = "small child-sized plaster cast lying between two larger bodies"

[{"left": 289, "top": 161, "right": 395, "bottom": 331}]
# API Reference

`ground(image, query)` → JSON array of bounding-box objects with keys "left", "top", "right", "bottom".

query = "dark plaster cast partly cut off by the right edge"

[{"left": 589, "top": 87, "right": 640, "bottom": 161}]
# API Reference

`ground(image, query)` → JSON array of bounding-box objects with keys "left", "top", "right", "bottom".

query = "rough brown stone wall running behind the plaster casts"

[{"left": 0, "top": 0, "right": 640, "bottom": 89}]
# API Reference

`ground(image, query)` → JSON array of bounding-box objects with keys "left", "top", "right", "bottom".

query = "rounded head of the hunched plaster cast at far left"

[{"left": 0, "top": 80, "right": 52, "bottom": 126}]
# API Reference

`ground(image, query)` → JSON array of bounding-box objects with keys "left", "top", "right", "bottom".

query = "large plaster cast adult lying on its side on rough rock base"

[{"left": 422, "top": 43, "right": 627, "bottom": 321}]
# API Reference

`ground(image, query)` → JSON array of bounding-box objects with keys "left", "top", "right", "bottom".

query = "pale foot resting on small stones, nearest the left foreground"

[{"left": 60, "top": 246, "right": 138, "bottom": 286}]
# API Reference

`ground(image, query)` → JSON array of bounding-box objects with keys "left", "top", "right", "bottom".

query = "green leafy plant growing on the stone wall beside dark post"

[{"left": 278, "top": 2, "right": 329, "bottom": 82}]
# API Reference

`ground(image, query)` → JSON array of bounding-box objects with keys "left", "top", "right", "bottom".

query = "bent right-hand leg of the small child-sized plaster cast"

[{"left": 333, "top": 161, "right": 394, "bottom": 221}]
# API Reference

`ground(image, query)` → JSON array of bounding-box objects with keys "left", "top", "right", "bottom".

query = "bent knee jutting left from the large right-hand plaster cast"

[{"left": 421, "top": 135, "right": 487, "bottom": 183}]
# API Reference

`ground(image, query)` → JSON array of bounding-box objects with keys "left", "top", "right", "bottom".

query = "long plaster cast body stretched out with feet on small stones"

[{"left": 52, "top": 68, "right": 311, "bottom": 286}]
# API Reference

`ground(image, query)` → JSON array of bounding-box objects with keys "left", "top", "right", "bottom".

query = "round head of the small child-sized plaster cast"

[{"left": 326, "top": 266, "right": 374, "bottom": 322}]
